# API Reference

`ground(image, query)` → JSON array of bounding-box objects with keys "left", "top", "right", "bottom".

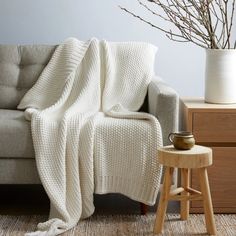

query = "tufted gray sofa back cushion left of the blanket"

[{"left": 0, "top": 45, "right": 56, "bottom": 109}]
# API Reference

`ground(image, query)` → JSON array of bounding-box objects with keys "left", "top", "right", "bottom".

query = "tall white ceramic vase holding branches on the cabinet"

[{"left": 205, "top": 49, "right": 236, "bottom": 104}]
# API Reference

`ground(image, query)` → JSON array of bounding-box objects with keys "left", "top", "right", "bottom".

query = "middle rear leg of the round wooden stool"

[{"left": 180, "top": 168, "right": 190, "bottom": 220}]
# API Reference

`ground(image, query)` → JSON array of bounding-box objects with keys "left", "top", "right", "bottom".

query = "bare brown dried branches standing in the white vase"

[{"left": 119, "top": 0, "right": 236, "bottom": 49}]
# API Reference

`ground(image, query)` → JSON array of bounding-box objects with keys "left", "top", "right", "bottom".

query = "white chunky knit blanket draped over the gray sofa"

[{"left": 18, "top": 38, "right": 162, "bottom": 235}]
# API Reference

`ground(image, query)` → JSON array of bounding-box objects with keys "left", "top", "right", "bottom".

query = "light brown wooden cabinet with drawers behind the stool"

[{"left": 183, "top": 99, "right": 236, "bottom": 213}]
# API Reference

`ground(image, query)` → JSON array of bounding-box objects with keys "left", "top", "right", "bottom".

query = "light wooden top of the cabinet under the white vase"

[{"left": 181, "top": 98, "right": 236, "bottom": 112}]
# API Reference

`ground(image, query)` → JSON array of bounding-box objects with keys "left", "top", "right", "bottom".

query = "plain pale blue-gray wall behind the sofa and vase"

[{"left": 0, "top": 0, "right": 205, "bottom": 96}]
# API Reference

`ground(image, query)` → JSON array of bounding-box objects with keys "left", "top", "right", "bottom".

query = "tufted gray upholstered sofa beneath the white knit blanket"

[{"left": 0, "top": 45, "right": 179, "bottom": 184}]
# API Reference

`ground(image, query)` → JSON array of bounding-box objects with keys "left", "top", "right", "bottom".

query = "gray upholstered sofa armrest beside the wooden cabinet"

[{"left": 148, "top": 77, "right": 179, "bottom": 145}]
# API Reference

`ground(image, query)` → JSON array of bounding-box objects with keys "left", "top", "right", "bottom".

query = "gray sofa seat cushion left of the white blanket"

[{"left": 0, "top": 109, "right": 34, "bottom": 158}]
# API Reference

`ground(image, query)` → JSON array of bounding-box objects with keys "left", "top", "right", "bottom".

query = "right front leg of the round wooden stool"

[{"left": 198, "top": 168, "right": 216, "bottom": 235}]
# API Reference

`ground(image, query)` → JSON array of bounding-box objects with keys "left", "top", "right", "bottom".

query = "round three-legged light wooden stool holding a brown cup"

[{"left": 154, "top": 145, "right": 216, "bottom": 235}]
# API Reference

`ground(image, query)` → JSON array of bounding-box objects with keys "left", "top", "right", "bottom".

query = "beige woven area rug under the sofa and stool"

[{"left": 0, "top": 214, "right": 236, "bottom": 236}]
